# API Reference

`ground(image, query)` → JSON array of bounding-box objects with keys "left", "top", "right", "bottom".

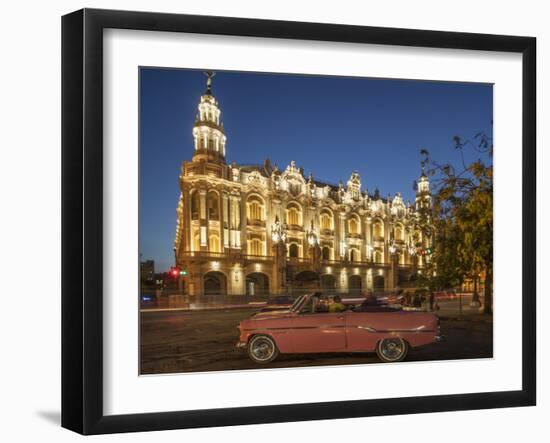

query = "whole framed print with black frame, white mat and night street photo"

[{"left": 62, "top": 9, "right": 536, "bottom": 434}]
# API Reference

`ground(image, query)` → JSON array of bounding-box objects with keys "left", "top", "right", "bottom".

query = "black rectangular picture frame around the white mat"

[{"left": 62, "top": 9, "right": 536, "bottom": 434}]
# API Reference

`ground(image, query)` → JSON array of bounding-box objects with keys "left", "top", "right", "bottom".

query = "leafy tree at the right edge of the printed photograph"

[{"left": 419, "top": 133, "right": 493, "bottom": 314}]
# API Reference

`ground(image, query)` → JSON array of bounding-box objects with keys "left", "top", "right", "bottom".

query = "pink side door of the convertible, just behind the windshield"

[{"left": 291, "top": 309, "right": 346, "bottom": 353}]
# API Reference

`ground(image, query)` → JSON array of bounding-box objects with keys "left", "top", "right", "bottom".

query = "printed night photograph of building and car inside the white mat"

[{"left": 136, "top": 66, "right": 494, "bottom": 377}]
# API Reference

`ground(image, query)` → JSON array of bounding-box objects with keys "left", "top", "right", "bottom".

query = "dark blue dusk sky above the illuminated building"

[{"left": 140, "top": 68, "right": 493, "bottom": 272}]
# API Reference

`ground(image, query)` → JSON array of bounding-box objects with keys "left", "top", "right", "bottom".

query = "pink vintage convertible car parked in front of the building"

[{"left": 237, "top": 294, "right": 442, "bottom": 363}]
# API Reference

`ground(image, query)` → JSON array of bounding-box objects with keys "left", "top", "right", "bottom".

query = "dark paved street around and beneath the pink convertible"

[{"left": 140, "top": 308, "right": 492, "bottom": 374}]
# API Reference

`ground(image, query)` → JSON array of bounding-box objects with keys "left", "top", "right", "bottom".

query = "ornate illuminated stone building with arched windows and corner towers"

[{"left": 174, "top": 74, "right": 432, "bottom": 295}]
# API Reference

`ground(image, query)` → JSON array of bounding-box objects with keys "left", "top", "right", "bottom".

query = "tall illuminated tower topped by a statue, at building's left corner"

[{"left": 193, "top": 72, "right": 227, "bottom": 163}]
